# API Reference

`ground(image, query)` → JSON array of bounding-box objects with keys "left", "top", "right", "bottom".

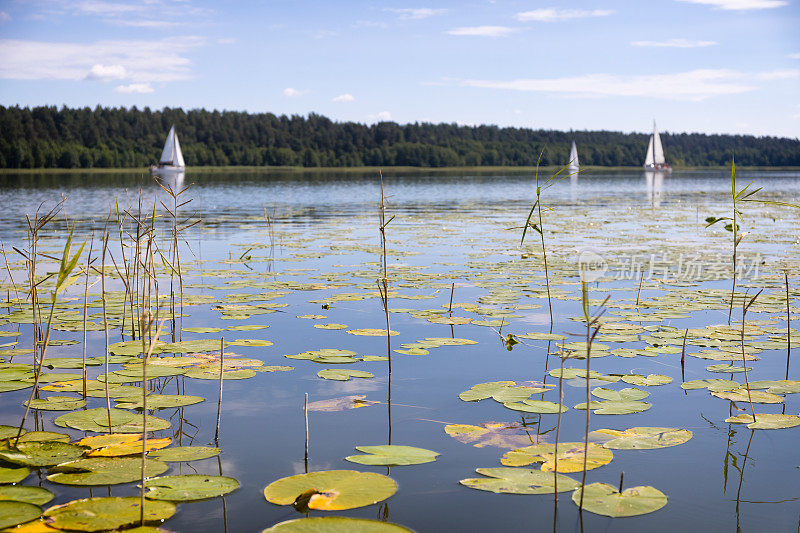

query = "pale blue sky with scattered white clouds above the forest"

[{"left": 0, "top": 0, "right": 800, "bottom": 138}]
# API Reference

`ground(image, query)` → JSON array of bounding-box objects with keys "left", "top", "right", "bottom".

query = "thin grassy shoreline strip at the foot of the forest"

[{"left": 0, "top": 165, "right": 800, "bottom": 175}]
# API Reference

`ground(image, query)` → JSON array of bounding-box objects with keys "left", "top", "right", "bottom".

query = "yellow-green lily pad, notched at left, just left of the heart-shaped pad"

[{"left": 459, "top": 467, "right": 580, "bottom": 494}]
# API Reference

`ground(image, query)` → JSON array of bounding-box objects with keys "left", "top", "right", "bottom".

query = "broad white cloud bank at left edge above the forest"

[{"left": 0, "top": 37, "right": 203, "bottom": 83}]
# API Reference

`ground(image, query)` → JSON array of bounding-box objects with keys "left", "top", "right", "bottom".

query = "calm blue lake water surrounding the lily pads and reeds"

[{"left": 0, "top": 171, "right": 800, "bottom": 532}]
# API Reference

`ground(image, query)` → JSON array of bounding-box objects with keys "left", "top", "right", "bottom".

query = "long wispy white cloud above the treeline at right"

[{"left": 458, "top": 69, "right": 800, "bottom": 101}]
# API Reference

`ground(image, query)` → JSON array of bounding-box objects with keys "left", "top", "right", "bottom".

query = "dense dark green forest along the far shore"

[{"left": 0, "top": 106, "right": 800, "bottom": 168}]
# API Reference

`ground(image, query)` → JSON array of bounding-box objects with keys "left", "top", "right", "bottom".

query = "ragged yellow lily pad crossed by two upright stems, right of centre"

[{"left": 500, "top": 442, "right": 614, "bottom": 472}]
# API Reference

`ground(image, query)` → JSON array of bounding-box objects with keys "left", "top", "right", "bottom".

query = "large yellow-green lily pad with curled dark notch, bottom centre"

[{"left": 264, "top": 470, "right": 397, "bottom": 511}]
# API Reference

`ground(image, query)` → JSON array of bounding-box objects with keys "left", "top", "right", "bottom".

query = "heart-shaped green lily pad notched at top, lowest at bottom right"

[{"left": 572, "top": 483, "right": 667, "bottom": 518}]
